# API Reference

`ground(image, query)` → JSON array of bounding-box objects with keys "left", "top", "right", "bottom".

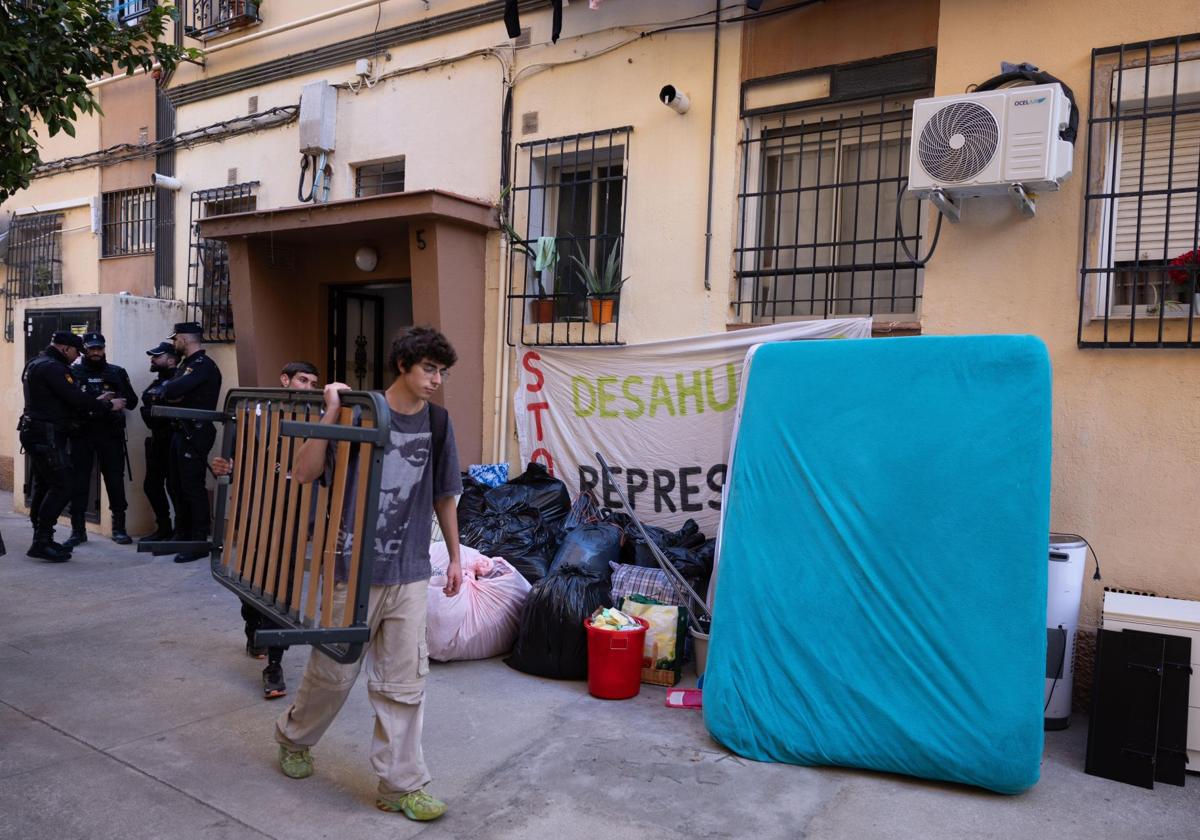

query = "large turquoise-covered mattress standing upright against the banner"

[{"left": 704, "top": 336, "right": 1050, "bottom": 793}]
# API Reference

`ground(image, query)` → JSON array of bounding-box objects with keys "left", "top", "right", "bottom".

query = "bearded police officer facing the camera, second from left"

[{"left": 64, "top": 332, "right": 138, "bottom": 548}]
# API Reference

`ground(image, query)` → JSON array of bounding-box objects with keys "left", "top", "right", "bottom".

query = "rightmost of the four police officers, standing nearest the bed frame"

[{"left": 160, "top": 322, "right": 221, "bottom": 563}]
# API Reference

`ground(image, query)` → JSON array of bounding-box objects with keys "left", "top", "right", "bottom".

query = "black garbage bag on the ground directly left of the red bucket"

[{"left": 504, "top": 566, "right": 612, "bottom": 679}]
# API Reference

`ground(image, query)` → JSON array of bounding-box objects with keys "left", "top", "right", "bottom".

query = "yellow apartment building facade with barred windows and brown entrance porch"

[{"left": 0, "top": 0, "right": 1200, "bottom": 700}]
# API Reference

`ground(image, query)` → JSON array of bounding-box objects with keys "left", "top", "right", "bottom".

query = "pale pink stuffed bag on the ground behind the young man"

[{"left": 425, "top": 542, "right": 532, "bottom": 662}]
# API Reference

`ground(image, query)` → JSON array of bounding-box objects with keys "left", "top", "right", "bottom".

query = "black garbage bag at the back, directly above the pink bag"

[{"left": 458, "top": 463, "right": 571, "bottom": 583}]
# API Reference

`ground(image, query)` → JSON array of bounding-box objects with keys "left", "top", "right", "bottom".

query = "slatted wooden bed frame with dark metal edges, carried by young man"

[{"left": 138, "top": 389, "right": 389, "bottom": 662}]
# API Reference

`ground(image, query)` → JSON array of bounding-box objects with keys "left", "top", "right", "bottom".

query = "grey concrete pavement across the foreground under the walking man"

[{"left": 0, "top": 493, "right": 1200, "bottom": 840}]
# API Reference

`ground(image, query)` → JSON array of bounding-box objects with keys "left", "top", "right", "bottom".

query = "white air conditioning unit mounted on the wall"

[{"left": 908, "top": 84, "right": 1075, "bottom": 199}]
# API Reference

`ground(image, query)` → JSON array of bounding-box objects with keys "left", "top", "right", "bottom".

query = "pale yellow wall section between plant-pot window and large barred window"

[{"left": 490, "top": 2, "right": 740, "bottom": 458}]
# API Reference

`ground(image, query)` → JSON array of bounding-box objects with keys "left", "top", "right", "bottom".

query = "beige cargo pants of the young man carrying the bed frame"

[{"left": 275, "top": 580, "right": 431, "bottom": 794}]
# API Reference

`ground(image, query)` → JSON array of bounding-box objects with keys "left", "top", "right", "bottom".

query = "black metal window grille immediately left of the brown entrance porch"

[{"left": 185, "top": 181, "right": 258, "bottom": 342}]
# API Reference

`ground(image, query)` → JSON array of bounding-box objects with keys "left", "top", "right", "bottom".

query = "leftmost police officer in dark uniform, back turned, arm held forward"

[{"left": 18, "top": 331, "right": 124, "bottom": 563}]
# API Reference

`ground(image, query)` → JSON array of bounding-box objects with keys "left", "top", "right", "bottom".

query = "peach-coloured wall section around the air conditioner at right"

[{"left": 924, "top": 0, "right": 1200, "bottom": 626}]
